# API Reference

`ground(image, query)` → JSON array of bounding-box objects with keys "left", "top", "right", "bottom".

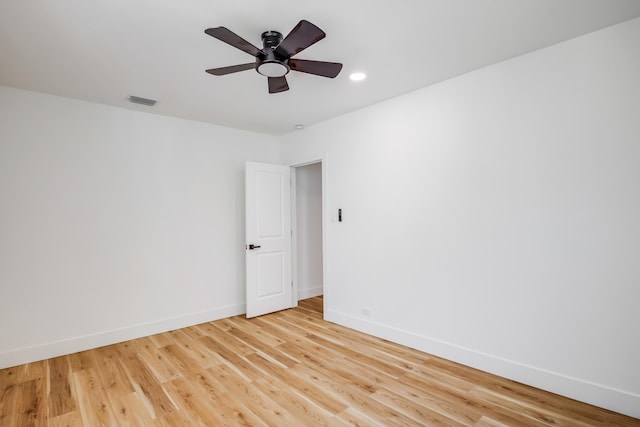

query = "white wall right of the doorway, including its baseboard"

[{"left": 282, "top": 19, "right": 640, "bottom": 417}]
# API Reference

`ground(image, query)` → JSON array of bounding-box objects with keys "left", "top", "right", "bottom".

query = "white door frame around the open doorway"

[{"left": 290, "top": 156, "right": 329, "bottom": 317}]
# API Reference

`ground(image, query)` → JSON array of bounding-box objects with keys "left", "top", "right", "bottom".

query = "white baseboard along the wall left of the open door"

[{"left": 0, "top": 304, "right": 246, "bottom": 369}]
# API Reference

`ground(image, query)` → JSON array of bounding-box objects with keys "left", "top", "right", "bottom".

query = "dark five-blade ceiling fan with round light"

[{"left": 204, "top": 20, "right": 342, "bottom": 93}]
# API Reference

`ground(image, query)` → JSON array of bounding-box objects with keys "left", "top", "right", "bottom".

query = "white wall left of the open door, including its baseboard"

[{"left": 0, "top": 87, "right": 278, "bottom": 368}]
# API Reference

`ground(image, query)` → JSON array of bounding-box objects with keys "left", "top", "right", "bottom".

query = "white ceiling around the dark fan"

[{"left": 0, "top": 0, "right": 640, "bottom": 135}]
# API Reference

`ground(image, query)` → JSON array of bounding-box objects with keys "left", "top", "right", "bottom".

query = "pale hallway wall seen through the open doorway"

[{"left": 295, "top": 163, "right": 323, "bottom": 299}]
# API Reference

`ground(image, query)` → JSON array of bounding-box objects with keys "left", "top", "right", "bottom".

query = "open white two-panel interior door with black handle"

[{"left": 245, "top": 162, "right": 294, "bottom": 317}]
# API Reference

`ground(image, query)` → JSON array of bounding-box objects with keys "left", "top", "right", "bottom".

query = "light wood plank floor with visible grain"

[{"left": 0, "top": 297, "right": 640, "bottom": 427}]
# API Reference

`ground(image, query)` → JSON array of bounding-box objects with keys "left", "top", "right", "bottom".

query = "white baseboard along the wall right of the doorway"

[{"left": 324, "top": 310, "right": 640, "bottom": 418}]
